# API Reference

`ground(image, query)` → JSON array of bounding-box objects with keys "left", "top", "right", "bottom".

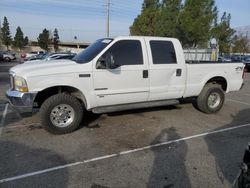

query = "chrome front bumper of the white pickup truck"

[{"left": 6, "top": 90, "right": 37, "bottom": 117}]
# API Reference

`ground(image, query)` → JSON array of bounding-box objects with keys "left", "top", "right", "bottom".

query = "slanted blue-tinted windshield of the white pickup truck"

[{"left": 72, "top": 38, "right": 113, "bottom": 63}]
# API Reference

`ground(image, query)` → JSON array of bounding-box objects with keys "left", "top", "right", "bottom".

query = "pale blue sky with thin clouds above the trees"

[{"left": 0, "top": 0, "right": 250, "bottom": 42}]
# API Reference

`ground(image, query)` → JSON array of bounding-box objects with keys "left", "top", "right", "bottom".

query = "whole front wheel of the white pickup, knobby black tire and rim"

[{"left": 40, "top": 93, "right": 83, "bottom": 134}]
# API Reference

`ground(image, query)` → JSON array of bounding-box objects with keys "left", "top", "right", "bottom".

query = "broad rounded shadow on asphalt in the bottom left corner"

[{"left": 0, "top": 141, "right": 68, "bottom": 188}]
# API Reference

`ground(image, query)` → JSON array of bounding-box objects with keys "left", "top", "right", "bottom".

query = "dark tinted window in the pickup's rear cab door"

[{"left": 150, "top": 40, "right": 177, "bottom": 64}]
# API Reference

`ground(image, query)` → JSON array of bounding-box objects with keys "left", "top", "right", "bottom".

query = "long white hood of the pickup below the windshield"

[{"left": 10, "top": 59, "right": 88, "bottom": 78}]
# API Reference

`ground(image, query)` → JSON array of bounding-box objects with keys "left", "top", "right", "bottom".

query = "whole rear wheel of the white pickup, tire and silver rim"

[{"left": 195, "top": 83, "right": 225, "bottom": 114}]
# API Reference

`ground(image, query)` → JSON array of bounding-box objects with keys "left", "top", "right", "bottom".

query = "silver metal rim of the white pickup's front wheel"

[{"left": 50, "top": 104, "right": 75, "bottom": 128}]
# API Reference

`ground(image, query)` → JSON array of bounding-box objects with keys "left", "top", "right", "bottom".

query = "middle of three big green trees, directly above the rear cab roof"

[{"left": 156, "top": 0, "right": 182, "bottom": 37}]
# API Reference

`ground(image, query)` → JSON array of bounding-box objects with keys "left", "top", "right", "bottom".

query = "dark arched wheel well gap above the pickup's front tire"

[{"left": 34, "top": 86, "right": 87, "bottom": 108}]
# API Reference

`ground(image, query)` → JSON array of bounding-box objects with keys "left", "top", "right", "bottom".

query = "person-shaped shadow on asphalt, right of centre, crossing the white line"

[{"left": 147, "top": 127, "right": 191, "bottom": 188}]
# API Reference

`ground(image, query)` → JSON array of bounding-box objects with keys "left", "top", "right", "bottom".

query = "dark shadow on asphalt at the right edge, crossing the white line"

[{"left": 205, "top": 109, "right": 250, "bottom": 185}]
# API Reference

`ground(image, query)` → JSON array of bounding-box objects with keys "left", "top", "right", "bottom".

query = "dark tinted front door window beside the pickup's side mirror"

[{"left": 104, "top": 40, "right": 143, "bottom": 66}]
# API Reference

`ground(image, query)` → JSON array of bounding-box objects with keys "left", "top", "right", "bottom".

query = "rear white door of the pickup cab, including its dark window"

[{"left": 146, "top": 38, "right": 185, "bottom": 100}]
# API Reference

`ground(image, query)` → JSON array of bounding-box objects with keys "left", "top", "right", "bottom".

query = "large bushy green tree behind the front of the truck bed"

[{"left": 178, "top": 0, "right": 217, "bottom": 47}]
